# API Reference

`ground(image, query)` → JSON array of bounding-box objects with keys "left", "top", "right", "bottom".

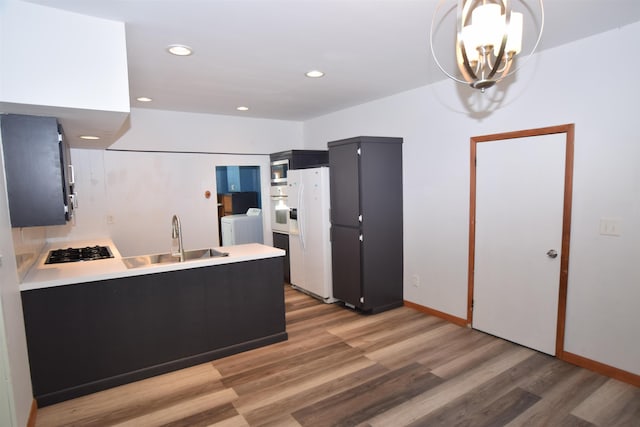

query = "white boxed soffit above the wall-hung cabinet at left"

[{"left": 0, "top": 0, "right": 130, "bottom": 148}]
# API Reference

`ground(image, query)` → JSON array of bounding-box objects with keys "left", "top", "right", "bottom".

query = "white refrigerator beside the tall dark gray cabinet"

[{"left": 287, "top": 167, "right": 336, "bottom": 303}]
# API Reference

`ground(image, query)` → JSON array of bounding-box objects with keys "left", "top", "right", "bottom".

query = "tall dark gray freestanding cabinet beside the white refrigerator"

[{"left": 327, "top": 136, "right": 403, "bottom": 313}]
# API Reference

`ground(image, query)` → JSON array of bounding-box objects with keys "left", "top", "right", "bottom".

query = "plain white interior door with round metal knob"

[{"left": 472, "top": 134, "right": 566, "bottom": 355}]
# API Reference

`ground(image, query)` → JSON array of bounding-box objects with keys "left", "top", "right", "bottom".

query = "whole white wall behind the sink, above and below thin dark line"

[{"left": 55, "top": 109, "right": 302, "bottom": 256}]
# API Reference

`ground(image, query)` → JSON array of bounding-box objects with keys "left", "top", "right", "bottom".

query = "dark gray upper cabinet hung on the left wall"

[{"left": 0, "top": 114, "right": 72, "bottom": 227}]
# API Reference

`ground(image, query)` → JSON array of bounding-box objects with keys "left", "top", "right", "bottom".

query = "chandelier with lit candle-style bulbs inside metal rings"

[{"left": 429, "top": 0, "right": 544, "bottom": 92}]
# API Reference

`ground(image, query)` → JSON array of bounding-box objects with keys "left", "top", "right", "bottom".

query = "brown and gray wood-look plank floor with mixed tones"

[{"left": 36, "top": 287, "right": 640, "bottom": 427}]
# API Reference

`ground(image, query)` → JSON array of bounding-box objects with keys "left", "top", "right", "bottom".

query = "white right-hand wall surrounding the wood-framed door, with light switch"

[{"left": 304, "top": 23, "right": 640, "bottom": 374}]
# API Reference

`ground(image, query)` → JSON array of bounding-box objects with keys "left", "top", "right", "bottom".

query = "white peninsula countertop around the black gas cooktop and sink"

[{"left": 20, "top": 239, "right": 285, "bottom": 291}]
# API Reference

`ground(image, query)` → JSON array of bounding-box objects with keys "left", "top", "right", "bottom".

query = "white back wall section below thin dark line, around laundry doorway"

[{"left": 105, "top": 151, "right": 272, "bottom": 256}]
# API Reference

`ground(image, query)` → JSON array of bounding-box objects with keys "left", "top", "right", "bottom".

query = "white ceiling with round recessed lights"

[{"left": 29, "top": 0, "right": 640, "bottom": 120}]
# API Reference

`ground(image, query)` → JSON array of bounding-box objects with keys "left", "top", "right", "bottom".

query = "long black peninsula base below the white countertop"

[{"left": 22, "top": 257, "right": 287, "bottom": 407}]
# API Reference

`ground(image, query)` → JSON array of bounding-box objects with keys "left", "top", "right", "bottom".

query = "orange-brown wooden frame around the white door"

[{"left": 467, "top": 123, "right": 575, "bottom": 359}]
